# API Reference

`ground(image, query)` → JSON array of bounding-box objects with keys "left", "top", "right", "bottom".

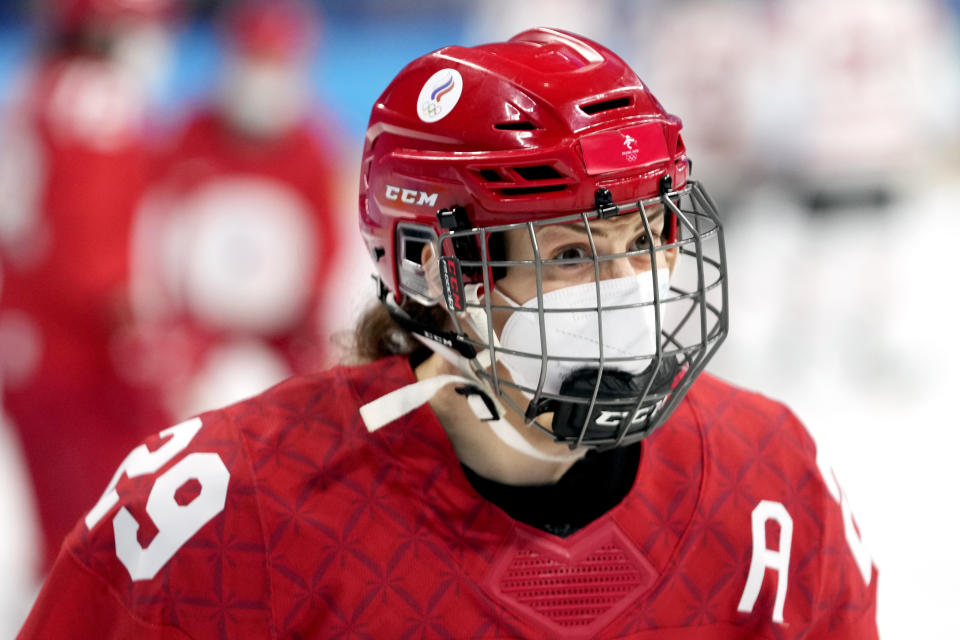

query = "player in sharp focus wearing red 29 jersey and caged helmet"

[{"left": 23, "top": 29, "right": 877, "bottom": 640}]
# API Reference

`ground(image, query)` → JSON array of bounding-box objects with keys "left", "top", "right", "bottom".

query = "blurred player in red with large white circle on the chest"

[{"left": 124, "top": 0, "right": 353, "bottom": 418}]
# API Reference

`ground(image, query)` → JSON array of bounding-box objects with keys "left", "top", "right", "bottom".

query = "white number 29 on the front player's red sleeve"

[{"left": 84, "top": 418, "right": 230, "bottom": 581}]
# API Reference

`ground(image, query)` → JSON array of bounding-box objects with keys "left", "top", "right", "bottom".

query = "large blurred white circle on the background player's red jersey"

[{"left": 165, "top": 176, "right": 320, "bottom": 335}]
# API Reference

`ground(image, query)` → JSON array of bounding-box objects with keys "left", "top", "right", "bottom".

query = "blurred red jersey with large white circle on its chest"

[{"left": 124, "top": 112, "right": 342, "bottom": 415}]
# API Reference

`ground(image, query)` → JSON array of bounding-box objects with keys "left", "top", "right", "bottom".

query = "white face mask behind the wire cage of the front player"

[{"left": 497, "top": 269, "right": 670, "bottom": 398}]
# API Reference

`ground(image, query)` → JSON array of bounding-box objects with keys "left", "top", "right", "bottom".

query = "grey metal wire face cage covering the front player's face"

[{"left": 435, "top": 181, "right": 728, "bottom": 449}]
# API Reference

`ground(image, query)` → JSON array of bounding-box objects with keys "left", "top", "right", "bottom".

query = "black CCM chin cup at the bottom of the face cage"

[{"left": 527, "top": 358, "right": 680, "bottom": 442}]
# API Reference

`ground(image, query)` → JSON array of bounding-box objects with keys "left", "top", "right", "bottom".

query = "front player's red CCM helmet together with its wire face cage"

[{"left": 359, "top": 28, "right": 727, "bottom": 447}]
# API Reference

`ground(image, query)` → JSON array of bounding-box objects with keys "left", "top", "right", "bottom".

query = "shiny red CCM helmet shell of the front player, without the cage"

[{"left": 360, "top": 29, "right": 689, "bottom": 300}]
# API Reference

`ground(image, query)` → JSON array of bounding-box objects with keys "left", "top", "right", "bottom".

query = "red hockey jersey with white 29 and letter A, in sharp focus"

[{"left": 22, "top": 358, "right": 877, "bottom": 640}]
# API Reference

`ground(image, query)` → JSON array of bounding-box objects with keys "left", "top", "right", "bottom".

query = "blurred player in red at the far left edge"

[{"left": 0, "top": 0, "right": 177, "bottom": 566}]
